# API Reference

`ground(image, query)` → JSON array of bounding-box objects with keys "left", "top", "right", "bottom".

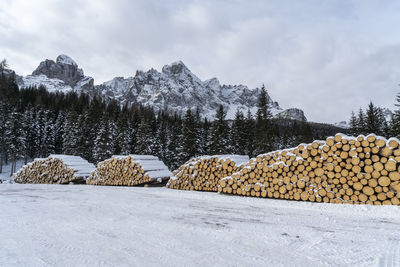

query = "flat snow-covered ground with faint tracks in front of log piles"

[{"left": 0, "top": 184, "right": 400, "bottom": 266}]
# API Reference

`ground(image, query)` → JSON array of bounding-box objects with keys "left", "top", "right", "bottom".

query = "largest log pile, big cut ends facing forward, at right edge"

[{"left": 218, "top": 134, "right": 400, "bottom": 205}]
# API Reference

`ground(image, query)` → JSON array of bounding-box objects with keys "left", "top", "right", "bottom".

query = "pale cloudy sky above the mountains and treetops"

[{"left": 0, "top": 0, "right": 400, "bottom": 122}]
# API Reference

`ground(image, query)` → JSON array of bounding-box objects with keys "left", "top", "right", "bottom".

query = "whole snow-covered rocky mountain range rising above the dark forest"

[{"left": 14, "top": 55, "right": 305, "bottom": 120}]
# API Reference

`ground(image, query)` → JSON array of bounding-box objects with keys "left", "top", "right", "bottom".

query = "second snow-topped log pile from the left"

[{"left": 86, "top": 155, "right": 172, "bottom": 186}]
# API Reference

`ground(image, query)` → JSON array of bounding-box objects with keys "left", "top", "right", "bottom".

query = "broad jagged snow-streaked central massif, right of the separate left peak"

[{"left": 95, "top": 61, "right": 282, "bottom": 119}]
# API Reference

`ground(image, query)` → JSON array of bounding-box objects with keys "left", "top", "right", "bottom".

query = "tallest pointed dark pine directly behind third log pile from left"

[{"left": 210, "top": 105, "right": 231, "bottom": 155}]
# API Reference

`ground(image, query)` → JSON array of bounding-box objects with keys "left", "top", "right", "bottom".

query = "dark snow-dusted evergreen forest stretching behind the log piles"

[{"left": 0, "top": 66, "right": 396, "bottom": 176}]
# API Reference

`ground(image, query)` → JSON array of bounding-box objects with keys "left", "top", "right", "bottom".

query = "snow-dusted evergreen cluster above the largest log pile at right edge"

[{"left": 349, "top": 100, "right": 400, "bottom": 138}]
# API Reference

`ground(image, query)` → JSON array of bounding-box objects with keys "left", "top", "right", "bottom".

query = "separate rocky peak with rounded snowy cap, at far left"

[{"left": 32, "top": 55, "right": 84, "bottom": 87}]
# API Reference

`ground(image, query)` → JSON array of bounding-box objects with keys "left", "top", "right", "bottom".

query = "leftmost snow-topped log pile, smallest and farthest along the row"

[{"left": 13, "top": 154, "right": 95, "bottom": 184}]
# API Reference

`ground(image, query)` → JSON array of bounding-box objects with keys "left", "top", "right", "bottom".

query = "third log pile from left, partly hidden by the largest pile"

[{"left": 167, "top": 155, "right": 249, "bottom": 192}]
